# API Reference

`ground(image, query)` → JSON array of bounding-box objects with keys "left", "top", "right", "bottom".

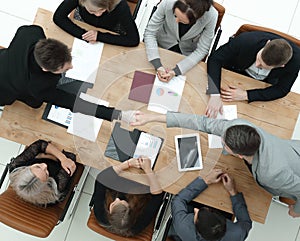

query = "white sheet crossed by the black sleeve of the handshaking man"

[{"left": 67, "top": 93, "right": 109, "bottom": 142}]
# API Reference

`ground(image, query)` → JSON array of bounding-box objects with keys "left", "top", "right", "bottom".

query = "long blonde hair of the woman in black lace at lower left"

[{"left": 9, "top": 166, "right": 60, "bottom": 206}]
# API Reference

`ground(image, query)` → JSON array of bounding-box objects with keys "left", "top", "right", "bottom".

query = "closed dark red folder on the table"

[{"left": 128, "top": 71, "right": 155, "bottom": 104}]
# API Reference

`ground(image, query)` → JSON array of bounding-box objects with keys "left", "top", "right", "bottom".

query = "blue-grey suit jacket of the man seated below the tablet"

[{"left": 172, "top": 177, "right": 252, "bottom": 241}]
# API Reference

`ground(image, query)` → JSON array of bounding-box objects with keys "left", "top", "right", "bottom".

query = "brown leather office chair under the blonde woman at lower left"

[{"left": 0, "top": 160, "right": 84, "bottom": 238}]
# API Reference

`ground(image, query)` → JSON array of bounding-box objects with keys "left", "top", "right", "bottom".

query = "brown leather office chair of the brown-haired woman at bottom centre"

[{"left": 87, "top": 193, "right": 171, "bottom": 241}]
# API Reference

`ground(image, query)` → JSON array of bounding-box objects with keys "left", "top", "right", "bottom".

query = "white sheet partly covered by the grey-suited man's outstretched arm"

[{"left": 208, "top": 105, "right": 237, "bottom": 148}]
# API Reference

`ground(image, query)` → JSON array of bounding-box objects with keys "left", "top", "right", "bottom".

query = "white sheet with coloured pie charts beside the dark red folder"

[{"left": 148, "top": 75, "right": 186, "bottom": 114}]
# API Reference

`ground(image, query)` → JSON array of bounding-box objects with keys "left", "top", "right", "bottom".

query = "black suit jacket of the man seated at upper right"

[{"left": 207, "top": 31, "right": 300, "bottom": 102}]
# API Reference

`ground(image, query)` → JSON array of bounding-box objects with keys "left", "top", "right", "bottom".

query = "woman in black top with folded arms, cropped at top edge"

[{"left": 53, "top": 0, "right": 140, "bottom": 47}]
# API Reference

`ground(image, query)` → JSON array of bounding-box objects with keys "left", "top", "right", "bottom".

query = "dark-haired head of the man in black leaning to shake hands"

[{"left": 33, "top": 39, "right": 73, "bottom": 74}]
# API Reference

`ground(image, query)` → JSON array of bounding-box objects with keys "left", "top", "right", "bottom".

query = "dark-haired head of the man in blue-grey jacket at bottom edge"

[{"left": 195, "top": 207, "right": 226, "bottom": 241}]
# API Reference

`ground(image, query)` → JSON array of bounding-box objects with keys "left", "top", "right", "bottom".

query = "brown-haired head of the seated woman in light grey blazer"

[{"left": 173, "top": 0, "right": 212, "bottom": 25}]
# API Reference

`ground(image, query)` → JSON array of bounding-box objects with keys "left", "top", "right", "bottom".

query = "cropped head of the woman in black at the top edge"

[{"left": 79, "top": 0, "right": 120, "bottom": 17}]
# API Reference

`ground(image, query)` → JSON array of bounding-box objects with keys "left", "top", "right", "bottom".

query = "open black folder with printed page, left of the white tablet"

[{"left": 104, "top": 122, "right": 164, "bottom": 168}]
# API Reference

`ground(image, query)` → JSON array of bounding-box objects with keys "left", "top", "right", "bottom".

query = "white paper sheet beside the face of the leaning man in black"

[{"left": 66, "top": 38, "right": 104, "bottom": 84}]
